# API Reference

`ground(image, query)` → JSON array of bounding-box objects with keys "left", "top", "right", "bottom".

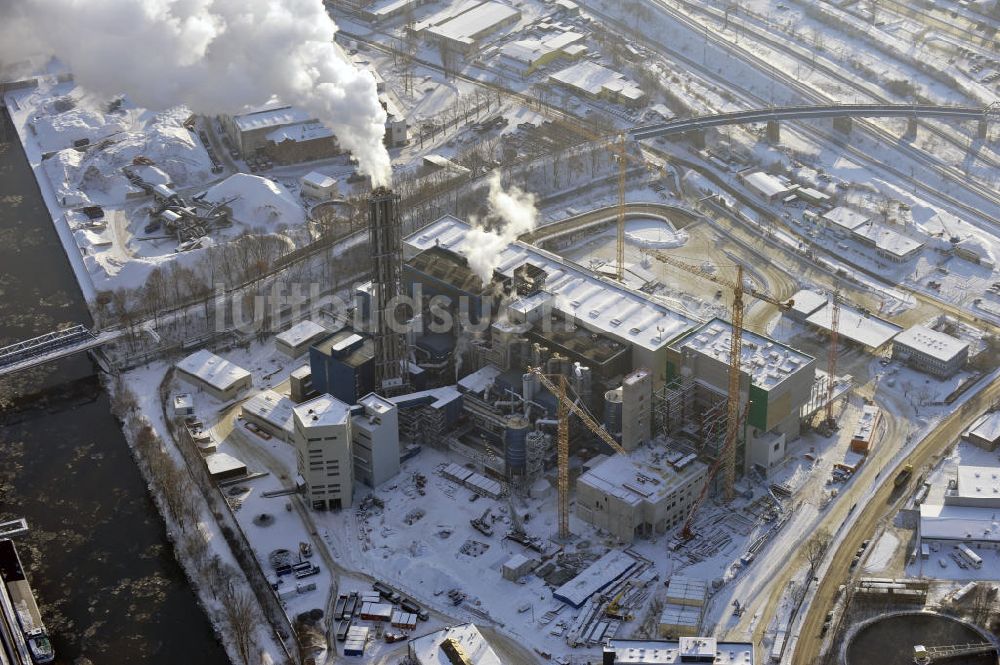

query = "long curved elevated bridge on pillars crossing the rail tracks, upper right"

[{"left": 629, "top": 102, "right": 1000, "bottom": 141}]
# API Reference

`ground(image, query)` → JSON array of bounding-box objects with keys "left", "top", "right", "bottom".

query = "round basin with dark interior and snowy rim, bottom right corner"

[{"left": 844, "top": 612, "right": 997, "bottom": 665}]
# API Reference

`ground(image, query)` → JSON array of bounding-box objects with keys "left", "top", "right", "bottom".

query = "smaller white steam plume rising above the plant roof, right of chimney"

[{"left": 464, "top": 172, "right": 538, "bottom": 285}]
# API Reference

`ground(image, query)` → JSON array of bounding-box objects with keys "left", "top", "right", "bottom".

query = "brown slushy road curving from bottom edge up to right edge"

[{"left": 792, "top": 370, "right": 1000, "bottom": 665}]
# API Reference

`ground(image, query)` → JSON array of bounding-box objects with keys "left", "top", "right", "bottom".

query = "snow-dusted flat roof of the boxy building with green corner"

[{"left": 677, "top": 319, "right": 813, "bottom": 389}]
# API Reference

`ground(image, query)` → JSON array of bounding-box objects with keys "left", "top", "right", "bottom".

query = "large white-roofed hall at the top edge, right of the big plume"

[{"left": 412, "top": 0, "right": 521, "bottom": 54}]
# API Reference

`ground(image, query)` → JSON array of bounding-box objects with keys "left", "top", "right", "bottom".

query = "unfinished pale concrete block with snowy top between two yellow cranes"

[{"left": 576, "top": 455, "right": 708, "bottom": 543}]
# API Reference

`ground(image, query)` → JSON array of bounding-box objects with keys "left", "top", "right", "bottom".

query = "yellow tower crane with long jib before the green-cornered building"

[{"left": 651, "top": 251, "right": 793, "bottom": 501}]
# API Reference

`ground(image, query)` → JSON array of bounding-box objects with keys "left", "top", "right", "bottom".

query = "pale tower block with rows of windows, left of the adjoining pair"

[{"left": 293, "top": 395, "right": 354, "bottom": 510}]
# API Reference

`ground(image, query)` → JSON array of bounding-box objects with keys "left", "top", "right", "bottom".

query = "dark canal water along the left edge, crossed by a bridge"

[{"left": 0, "top": 110, "right": 228, "bottom": 665}]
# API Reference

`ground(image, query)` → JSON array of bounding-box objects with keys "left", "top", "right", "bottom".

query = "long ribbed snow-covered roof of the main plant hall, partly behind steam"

[{"left": 404, "top": 215, "right": 697, "bottom": 351}]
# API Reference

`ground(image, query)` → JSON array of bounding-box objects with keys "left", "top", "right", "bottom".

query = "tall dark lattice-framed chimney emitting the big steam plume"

[{"left": 368, "top": 187, "right": 409, "bottom": 395}]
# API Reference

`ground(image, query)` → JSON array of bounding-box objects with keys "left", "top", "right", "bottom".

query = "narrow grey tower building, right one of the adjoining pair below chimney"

[{"left": 351, "top": 393, "right": 399, "bottom": 487}]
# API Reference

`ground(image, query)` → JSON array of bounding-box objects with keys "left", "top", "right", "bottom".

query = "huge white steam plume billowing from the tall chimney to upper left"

[{"left": 0, "top": 0, "right": 391, "bottom": 185}]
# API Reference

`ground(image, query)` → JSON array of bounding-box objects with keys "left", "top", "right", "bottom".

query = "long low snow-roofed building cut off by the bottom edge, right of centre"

[{"left": 601, "top": 637, "right": 754, "bottom": 665}]
